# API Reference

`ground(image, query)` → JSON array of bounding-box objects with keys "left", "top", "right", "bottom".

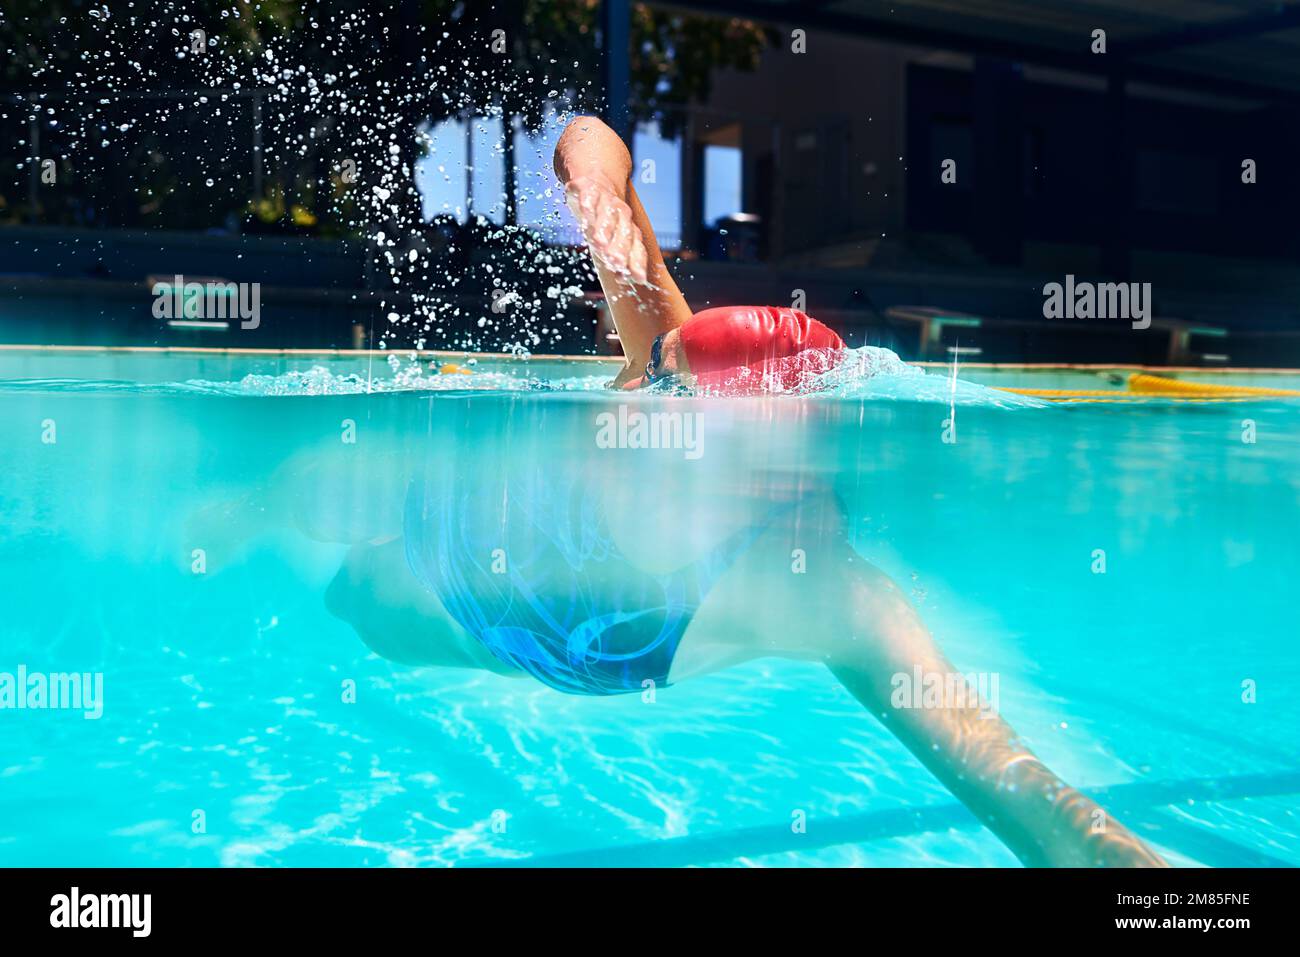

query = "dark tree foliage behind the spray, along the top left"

[{"left": 0, "top": 0, "right": 766, "bottom": 228}]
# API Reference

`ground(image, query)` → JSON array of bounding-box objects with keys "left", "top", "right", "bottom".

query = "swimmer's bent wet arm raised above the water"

[{"left": 555, "top": 116, "right": 690, "bottom": 386}]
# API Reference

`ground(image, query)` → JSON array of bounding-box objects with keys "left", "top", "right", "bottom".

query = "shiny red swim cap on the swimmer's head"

[{"left": 677, "top": 306, "right": 845, "bottom": 394}]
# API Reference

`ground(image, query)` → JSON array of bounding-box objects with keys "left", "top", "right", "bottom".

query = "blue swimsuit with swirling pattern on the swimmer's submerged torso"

[{"left": 404, "top": 473, "right": 762, "bottom": 694}]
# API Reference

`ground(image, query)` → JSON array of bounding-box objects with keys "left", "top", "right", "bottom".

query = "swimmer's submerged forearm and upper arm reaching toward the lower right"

[{"left": 827, "top": 558, "right": 1167, "bottom": 867}]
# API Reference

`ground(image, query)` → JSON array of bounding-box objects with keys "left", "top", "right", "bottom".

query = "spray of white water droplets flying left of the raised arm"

[{"left": 0, "top": 0, "right": 599, "bottom": 352}]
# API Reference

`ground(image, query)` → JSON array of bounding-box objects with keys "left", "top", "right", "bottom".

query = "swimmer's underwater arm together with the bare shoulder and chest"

[{"left": 681, "top": 493, "right": 1166, "bottom": 867}]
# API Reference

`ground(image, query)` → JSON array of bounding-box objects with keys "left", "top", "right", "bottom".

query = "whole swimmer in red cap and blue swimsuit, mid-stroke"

[{"left": 212, "top": 111, "right": 1167, "bottom": 867}]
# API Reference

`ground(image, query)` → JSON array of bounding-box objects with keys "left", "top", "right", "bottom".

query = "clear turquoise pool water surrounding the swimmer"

[{"left": 0, "top": 354, "right": 1300, "bottom": 866}]
